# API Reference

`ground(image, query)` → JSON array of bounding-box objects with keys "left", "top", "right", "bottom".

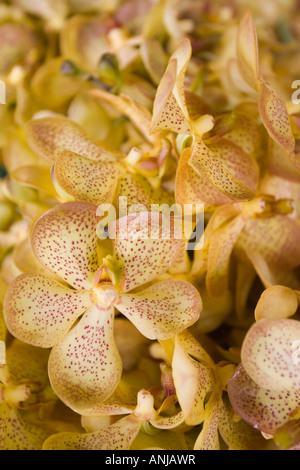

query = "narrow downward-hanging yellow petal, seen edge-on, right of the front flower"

[{"left": 206, "top": 215, "right": 246, "bottom": 296}]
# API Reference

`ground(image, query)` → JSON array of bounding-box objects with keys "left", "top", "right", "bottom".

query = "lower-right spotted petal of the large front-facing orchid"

[{"left": 114, "top": 279, "right": 202, "bottom": 340}]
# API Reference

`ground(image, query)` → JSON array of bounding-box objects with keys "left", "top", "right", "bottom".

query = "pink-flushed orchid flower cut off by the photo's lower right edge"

[{"left": 228, "top": 318, "right": 300, "bottom": 448}]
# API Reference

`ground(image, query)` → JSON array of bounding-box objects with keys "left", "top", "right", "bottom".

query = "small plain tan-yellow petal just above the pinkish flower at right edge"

[{"left": 255, "top": 285, "right": 298, "bottom": 321}]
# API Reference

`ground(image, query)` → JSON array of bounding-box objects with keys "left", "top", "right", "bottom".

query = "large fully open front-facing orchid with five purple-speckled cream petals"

[{"left": 4, "top": 202, "right": 201, "bottom": 414}]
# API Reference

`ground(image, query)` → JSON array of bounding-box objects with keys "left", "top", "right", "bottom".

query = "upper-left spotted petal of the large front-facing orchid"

[{"left": 31, "top": 202, "right": 99, "bottom": 289}]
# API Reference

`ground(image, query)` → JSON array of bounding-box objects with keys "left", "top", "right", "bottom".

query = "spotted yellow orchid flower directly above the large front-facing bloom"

[{"left": 25, "top": 116, "right": 173, "bottom": 209}]
